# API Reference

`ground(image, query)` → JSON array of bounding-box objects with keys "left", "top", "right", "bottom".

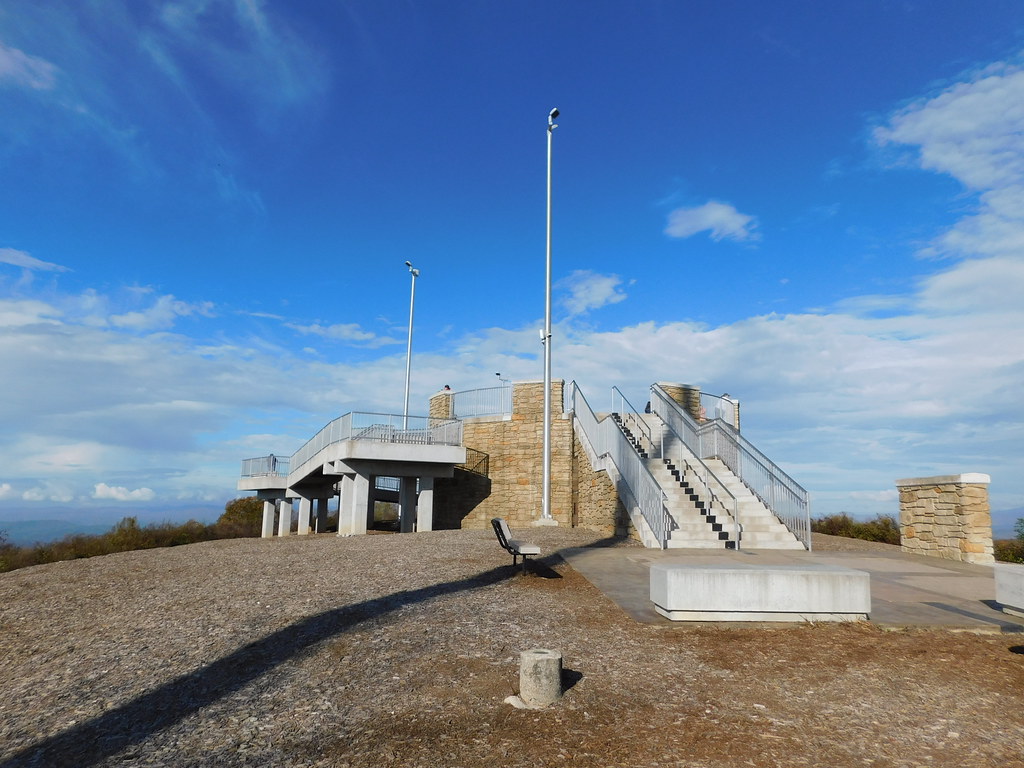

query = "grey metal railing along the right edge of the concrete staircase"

[{"left": 650, "top": 384, "right": 811, "bottom": 550}]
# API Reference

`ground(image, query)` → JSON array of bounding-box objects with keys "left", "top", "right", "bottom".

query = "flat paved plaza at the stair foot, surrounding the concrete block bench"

[{"left": 560, "top": 547, "right": 1024, "bottom": 633}]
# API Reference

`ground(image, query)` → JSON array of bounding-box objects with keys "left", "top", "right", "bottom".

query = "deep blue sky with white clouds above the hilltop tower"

[{"left": 0, "top": 0, "right": 1024, "bottom": 536}]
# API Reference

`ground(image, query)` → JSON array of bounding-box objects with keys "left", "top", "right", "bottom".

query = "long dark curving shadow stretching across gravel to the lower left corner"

[{"left": 0, "top": 536, "right": 614, "bottom": 768}]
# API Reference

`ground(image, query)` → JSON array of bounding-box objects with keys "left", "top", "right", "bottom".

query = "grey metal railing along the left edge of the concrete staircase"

[{"left": 569, "top": 382, "right": 671, "bottom": 549}]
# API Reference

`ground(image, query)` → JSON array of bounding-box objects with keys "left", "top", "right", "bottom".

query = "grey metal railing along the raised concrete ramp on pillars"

[{"left": 242, "top": 412, "right": 462, "bottom": 477}]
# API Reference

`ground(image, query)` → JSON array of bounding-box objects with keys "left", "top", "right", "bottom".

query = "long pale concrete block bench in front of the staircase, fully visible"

[{"left": 650, "top": 563, "right": 871, "bottom": 622}]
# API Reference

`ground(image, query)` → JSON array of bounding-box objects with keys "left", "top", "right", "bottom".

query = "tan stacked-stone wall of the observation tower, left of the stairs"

[{"left": 430, "top": 380, "right": 628, "bottom": 535}]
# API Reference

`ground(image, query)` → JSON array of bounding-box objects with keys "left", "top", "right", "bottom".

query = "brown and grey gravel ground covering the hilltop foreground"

[{"left": 0, "top": 528, "right": 1024, "bottom": 768}]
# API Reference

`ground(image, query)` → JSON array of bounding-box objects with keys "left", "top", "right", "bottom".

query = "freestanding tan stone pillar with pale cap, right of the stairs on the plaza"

[{"left": 896, "top": 472, "right": 995, "bottom": 563}]
